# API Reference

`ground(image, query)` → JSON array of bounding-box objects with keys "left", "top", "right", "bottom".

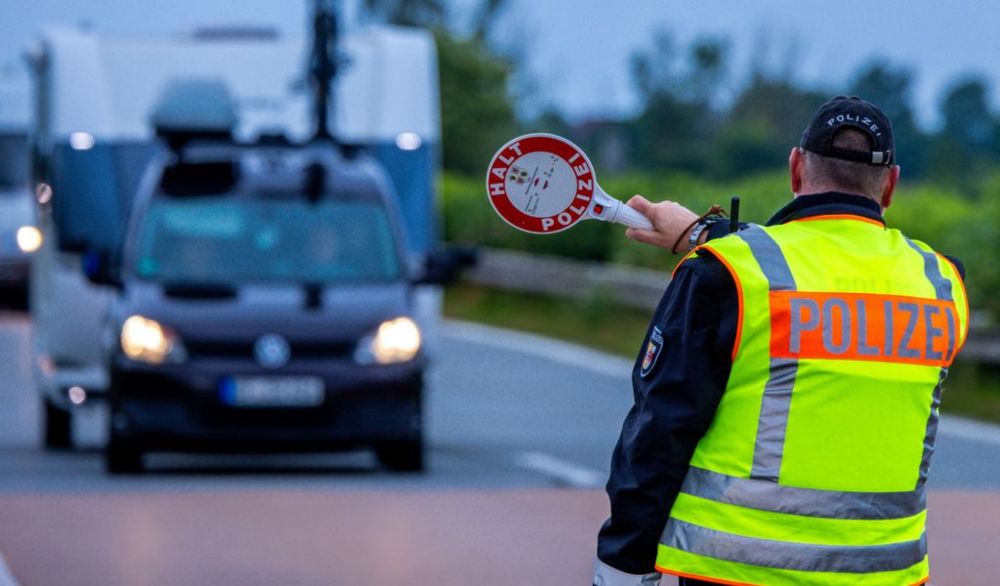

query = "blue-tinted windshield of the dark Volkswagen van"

[{"left": 135, "top": 196, "right": 400, "bottom": 284}]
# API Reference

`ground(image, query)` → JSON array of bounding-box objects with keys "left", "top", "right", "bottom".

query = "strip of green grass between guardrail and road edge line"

[{"left": 445, "top": 284, "right": 1000, "bottom": 423}]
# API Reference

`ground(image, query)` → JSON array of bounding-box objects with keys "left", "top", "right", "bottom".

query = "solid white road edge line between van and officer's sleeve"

[{"left": 443, "top": 320, "right": 632, "bottom": 378}]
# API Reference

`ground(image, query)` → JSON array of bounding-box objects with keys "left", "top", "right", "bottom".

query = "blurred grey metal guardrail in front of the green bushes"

[{"left": 466, "top": 248, "right": 1000, "bottom": 365}]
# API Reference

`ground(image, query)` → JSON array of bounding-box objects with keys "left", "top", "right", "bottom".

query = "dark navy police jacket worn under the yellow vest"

[{"left": 597, "top": 192, "right": 965, "bottom": 574}]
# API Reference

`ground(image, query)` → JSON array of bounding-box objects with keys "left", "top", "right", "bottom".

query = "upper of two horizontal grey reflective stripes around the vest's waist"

[{"left": 681, "top": 466, "right": 926, "bottom": 521}]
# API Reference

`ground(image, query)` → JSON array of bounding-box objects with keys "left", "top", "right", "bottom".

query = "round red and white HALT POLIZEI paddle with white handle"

[{"left": 486, "top": 134, "right": 653, "bottom": 234}]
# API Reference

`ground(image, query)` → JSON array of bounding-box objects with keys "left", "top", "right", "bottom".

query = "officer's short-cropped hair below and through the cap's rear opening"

[{"left": 803, "top": 128, "right": 889, "bottom": 201}]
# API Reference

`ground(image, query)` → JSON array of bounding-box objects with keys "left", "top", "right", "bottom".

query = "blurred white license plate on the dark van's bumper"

[{"left": 219, "top": 376, "right": 325, "bottom": 407}]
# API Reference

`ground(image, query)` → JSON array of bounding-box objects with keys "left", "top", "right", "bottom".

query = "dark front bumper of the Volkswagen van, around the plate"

[{"left": 110, "top": 360, "right": 423, "bottom": 452}]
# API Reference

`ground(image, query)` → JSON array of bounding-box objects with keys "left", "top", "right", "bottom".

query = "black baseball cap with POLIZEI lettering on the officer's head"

[{"left": 799, "top": 96, "right": 896, "bottom": 166}]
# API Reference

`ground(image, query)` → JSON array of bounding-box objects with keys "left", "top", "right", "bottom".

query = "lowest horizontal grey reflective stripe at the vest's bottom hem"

[{"left": 663, "top": 519, "right": 927, "bottom": 574}]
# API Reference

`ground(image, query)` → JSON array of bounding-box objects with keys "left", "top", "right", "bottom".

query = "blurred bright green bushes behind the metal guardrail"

[{"left": 441, "top": 170, "right": 1000, "bottom": 317}]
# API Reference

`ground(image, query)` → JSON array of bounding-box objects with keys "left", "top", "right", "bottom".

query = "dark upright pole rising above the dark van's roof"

[{"left": 309, "top": 0, "right": 338, "bottom": 143}]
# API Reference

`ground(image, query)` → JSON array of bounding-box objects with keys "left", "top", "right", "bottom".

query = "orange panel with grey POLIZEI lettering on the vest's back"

[{"left": 770, "top": 291, "right": 957, "bottom": 366}]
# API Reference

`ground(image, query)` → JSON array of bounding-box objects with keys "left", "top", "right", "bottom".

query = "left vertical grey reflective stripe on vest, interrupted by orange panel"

[{"left": 737, "top": 226, "right": 799, "bottom": 482}]
